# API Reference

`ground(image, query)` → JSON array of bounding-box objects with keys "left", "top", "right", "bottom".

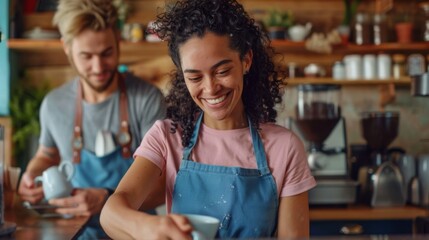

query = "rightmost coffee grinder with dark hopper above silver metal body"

[{"left": 359, "top": 111, "right": 406, "bottom": 207}]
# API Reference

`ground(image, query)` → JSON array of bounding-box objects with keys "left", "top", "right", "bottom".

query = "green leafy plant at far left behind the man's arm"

[{"left": 9, "top": 81, "right": 49, "bottom": 169}]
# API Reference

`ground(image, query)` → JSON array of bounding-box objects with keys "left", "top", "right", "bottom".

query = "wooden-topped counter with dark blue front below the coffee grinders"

[{"left": 310, "top": 205, "right": 429, "bottom": 236}]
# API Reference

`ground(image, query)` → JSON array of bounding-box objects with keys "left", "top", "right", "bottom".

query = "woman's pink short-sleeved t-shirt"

[{"left": 134, "top": 120, "right": 316, "bottom": 212}]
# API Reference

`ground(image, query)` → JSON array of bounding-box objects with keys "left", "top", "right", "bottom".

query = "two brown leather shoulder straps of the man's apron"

[{"left": 72, "top": 74, "right": 131, "bottom": 163}]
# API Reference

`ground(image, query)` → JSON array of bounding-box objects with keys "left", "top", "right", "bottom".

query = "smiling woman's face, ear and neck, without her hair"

[{"left": 180, "top": 32, "right": 252, "bottom": 130}]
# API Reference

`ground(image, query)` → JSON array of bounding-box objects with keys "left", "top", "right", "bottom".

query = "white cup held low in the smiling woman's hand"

[{"left": 184, "top": 214, "right": 220, "bottom": 240}]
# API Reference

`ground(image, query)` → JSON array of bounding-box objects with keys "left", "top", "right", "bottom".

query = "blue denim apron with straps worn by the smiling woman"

[{"left": 172, "top": 114, "right": 279, "bottom": 238}]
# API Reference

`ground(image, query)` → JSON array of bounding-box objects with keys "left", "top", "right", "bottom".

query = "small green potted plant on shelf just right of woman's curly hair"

[{"left": 265, "top": 9, "right": 293, "bottom": 39}]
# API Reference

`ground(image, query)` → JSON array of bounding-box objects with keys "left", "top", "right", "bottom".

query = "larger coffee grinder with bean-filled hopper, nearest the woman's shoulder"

[{"left": 289, "top": 84, "right": 358, "bottom": 205}]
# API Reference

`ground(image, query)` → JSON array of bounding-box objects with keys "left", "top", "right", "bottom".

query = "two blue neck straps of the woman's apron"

[{"left": 182, "top": 112, "right": 270, "bottom": 172}]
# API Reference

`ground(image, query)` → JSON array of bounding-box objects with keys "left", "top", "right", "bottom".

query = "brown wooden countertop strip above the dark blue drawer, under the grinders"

[{"left": 310, "top": 206, "right": 429, "bottom": 220}]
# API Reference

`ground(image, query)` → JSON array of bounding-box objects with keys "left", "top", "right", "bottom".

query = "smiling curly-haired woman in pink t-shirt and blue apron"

[{"left": 101, "top": 0, "right": 316, "bottom": 239}]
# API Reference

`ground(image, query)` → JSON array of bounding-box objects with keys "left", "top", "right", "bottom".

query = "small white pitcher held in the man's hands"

[{"left": 34, "top": 162, "right": 74, "bottom": 200}]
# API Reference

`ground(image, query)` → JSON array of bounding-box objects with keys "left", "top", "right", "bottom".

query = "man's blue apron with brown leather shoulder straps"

[{"left": 72, "top": 75, "right": 133, "bottom": 239}]
